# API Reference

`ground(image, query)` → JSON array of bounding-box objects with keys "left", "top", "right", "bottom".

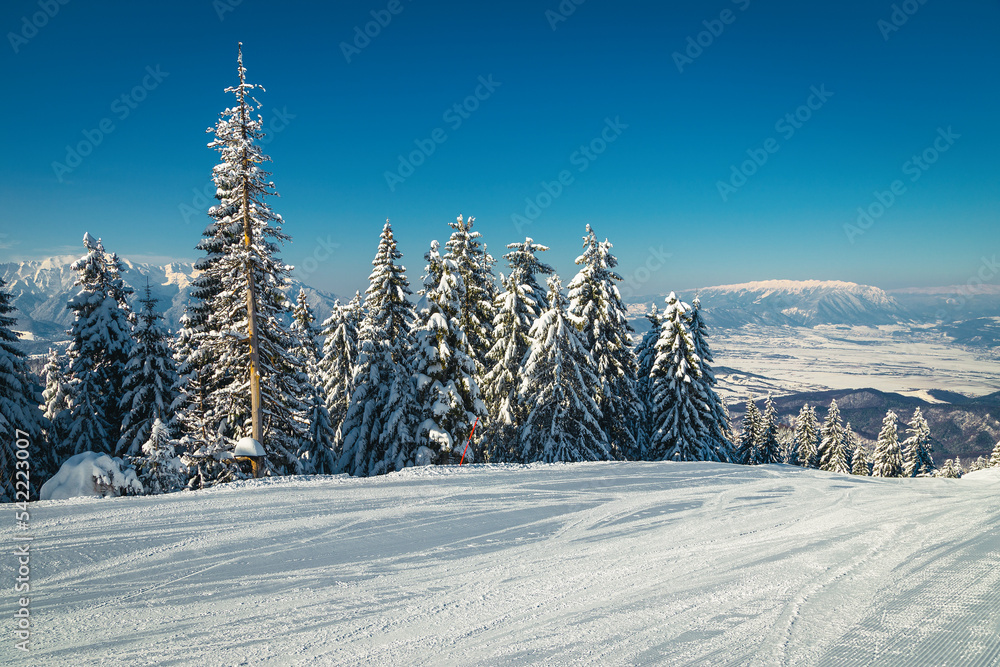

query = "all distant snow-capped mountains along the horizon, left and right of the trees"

[{"left": 0, "top": 255, "right": 1000, "bottom": 354}]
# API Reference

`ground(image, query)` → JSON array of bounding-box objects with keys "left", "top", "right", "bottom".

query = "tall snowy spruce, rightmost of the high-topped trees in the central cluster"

[{"left": 568, "top": 225, "right": 636, "bottom": 460}]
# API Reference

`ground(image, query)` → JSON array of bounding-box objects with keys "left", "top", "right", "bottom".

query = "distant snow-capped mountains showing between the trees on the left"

[{"left": 0, "top": 255, "right": 336, "bottom": 354}]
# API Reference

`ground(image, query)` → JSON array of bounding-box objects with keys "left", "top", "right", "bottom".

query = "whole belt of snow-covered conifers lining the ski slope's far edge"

[{"left": 7, "top": 52, "right": 997, "bottom": 501}]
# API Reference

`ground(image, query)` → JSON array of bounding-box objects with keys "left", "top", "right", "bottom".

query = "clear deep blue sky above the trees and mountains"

[{"left": 0, "top": 0, "right": 1000, "bottom": 294}]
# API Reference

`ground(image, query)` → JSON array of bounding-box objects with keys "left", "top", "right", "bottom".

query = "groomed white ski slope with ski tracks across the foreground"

[{"left": 9, "top": 463, "right": 1000, "bottom": 667}]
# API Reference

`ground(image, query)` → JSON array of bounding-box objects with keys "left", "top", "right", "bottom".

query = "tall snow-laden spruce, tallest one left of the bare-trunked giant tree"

[{"left": 59, "top": 234, "right": 132, "bottom": 461}]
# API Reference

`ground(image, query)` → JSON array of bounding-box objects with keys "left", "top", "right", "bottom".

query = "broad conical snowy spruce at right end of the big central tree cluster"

[{"left": 646, "top": 292, "right": 720, "bottom": 461}]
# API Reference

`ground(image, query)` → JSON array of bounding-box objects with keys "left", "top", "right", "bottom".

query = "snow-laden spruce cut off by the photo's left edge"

[{"left": 0, "top": 279, "right": 47, "bottom": 502}]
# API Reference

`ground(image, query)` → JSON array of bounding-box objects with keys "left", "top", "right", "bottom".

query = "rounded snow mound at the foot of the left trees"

[{"left": 38, "top": 452, "right": 143, "bottom": 500}]
